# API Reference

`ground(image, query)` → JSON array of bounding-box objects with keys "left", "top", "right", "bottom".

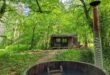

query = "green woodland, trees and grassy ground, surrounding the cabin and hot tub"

[{"left": 0, "top": 0, "right": 110, "bottom": 75}]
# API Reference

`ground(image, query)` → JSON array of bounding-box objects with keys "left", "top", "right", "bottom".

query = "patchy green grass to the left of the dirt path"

[{"left": 0, "top": 50, "right": 46, "bottom": 75}]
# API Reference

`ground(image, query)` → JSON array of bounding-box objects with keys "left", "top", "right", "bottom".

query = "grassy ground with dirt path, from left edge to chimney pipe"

[{"left": 0, "top": 49, "right": 108, "bottom": 75}]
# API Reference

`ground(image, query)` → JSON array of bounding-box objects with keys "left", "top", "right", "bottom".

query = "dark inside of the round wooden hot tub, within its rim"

[{"left": 24, "top": 61, "right": 106, "bottom": 75}]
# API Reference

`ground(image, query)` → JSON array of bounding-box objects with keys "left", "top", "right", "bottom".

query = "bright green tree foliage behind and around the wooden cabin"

[{"left": 0, "top": 0, "right": 93, "bottom": 49}]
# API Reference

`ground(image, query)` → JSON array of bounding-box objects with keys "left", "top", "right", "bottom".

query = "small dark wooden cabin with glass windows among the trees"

[{"left": 50, "top": 35, "right": 79, "bottom": 49}]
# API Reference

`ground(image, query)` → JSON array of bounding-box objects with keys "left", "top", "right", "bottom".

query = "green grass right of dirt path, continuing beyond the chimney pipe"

[{"left": 53, "top": 49, "right": 110, "bottom": 75}]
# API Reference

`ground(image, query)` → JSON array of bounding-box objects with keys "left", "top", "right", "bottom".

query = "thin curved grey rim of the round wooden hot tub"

[{"left": 23, "top": 61, "right": 108, "bottom": 75}]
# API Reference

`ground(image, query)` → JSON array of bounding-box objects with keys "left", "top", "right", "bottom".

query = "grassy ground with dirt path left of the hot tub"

[{"left": 0, "top": 50, "right": 63, "bottom": 75}]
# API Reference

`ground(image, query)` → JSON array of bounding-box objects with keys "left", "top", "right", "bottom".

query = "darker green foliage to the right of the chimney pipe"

[{"left": 100, "top": 0, "right": 110, "bottom": 62}]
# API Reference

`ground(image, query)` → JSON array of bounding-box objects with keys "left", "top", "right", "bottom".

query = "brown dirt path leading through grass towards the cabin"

[{"left": 37, "top": 50, "right": 60, "bottom": 63}]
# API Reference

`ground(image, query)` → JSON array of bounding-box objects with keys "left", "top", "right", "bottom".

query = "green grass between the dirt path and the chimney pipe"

[{"left": 54, "top": 49, "right": 93, "bottom": 63}]
